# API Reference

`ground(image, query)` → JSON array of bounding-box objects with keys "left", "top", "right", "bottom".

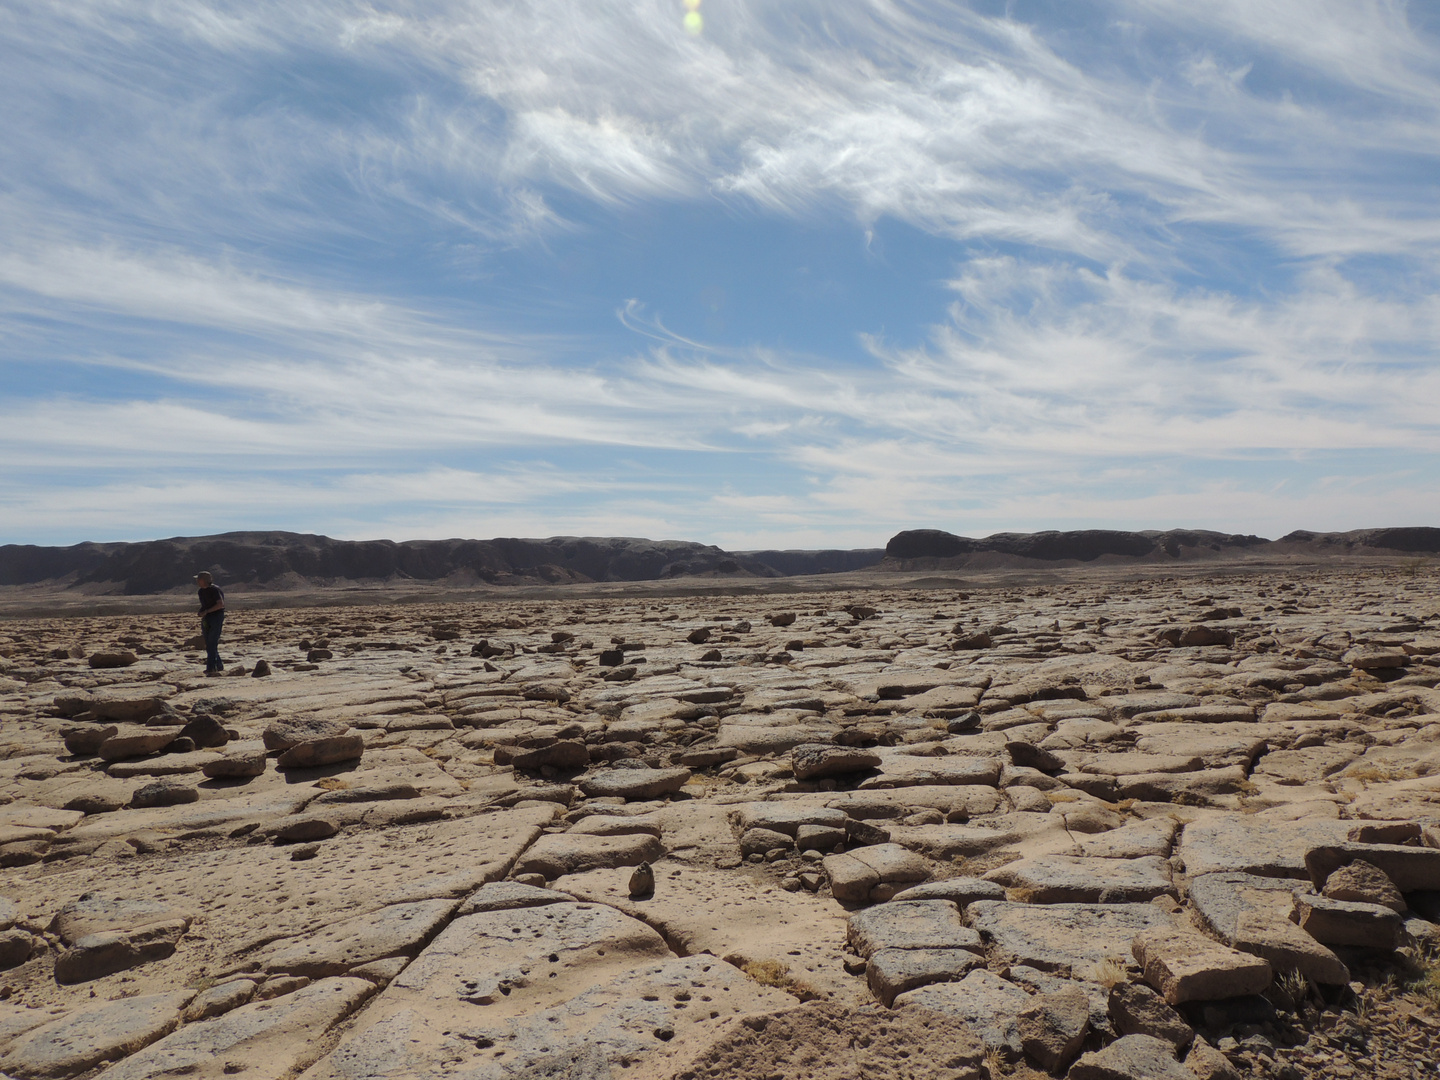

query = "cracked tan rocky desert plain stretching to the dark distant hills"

[{"left": 0, "top": 562, "right": 1440, "bottom": 1080}]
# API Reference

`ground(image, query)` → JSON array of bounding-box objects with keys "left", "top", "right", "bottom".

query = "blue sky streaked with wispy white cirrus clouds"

[{"left": 0, "top": 0, "right": 1440, "bottom": 550}]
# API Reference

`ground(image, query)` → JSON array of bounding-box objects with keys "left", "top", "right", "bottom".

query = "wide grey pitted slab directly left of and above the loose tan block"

[{"left": 966, "top": 900, "right": 1172, "bottom": 975}]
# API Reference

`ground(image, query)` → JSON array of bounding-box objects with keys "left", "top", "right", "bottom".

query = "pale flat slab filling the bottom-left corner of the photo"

[{"left": 0, "top": 991, "right": 194, "bottom": 1080}]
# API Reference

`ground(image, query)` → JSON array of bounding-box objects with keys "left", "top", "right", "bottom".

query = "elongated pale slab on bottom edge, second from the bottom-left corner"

[{"left": 101, "top": 979, "right": 374, "bottom": 1080}]
